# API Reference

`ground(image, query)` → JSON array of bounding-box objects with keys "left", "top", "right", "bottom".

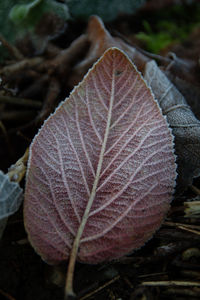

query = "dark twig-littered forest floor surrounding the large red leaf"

[{"left": 0, "top": 4, "right": 200, "bottom": 300}]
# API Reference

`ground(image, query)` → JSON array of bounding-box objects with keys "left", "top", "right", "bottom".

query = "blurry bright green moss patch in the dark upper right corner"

[{"left": 136, "top": 4, "right": 200, "bottom": 53}]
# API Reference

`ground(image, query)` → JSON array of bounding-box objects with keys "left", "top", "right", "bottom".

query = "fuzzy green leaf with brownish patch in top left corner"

[{"left": 0, "top": 0, "right": 70, "bottom": 61}]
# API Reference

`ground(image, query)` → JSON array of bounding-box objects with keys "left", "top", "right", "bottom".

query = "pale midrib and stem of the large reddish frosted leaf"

[{"left": 65, "top": 58, "right": 115, "bottom": 299}]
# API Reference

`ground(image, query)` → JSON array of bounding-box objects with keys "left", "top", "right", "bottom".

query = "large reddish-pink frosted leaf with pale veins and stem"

[{"left": 24, "top": 48, "right": 176, "bottom": 291}]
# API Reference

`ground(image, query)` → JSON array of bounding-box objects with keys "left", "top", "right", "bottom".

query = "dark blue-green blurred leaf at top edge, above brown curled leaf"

[{"left": 66, "top": 0, "right": 145, "bottom": 21}]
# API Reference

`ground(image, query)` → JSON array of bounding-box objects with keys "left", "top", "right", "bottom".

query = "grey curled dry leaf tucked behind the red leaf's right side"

[{"left": 144, "top": 61, "right": 200, "bottom": 193}]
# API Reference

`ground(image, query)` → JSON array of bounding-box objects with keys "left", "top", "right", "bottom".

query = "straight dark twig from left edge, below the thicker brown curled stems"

[{"left": 0, "top": 94, "right": 42, "bottom": 109}]
